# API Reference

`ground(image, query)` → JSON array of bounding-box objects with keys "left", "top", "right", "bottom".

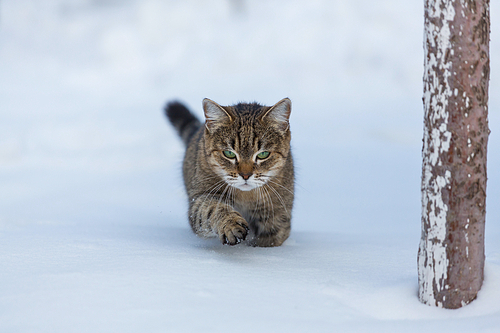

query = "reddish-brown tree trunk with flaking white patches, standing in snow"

[{"left": 418, "top": 0, "right": 490, "bottom": 309}]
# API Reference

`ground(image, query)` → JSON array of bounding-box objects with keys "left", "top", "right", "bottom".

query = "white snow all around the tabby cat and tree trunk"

[{"left": 0, "top": 0, "right": 500, "bottom": 332}]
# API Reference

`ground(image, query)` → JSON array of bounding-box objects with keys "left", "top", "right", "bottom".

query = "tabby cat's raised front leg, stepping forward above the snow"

[{"left": 189, "top": 195, "right": 249, "bottom": 245}]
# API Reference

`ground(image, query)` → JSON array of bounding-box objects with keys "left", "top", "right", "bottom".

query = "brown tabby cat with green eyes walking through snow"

[{"left": 165, "top": 98, "right": 294, "bottom": 247}]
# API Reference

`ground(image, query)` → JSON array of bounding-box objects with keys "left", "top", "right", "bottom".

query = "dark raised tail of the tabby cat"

[{"left": 165, "top": 101, "right": 202, "bottom": 145}]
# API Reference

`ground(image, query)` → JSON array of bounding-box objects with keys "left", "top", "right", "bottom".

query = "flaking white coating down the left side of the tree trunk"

[{"left": 418, "top": 0, "right": 458, "bottom": 307}]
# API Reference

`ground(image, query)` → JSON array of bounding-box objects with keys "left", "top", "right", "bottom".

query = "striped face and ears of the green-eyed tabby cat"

[{"left": 203, "top": 98, "right": 291, "bottom": 191}]
